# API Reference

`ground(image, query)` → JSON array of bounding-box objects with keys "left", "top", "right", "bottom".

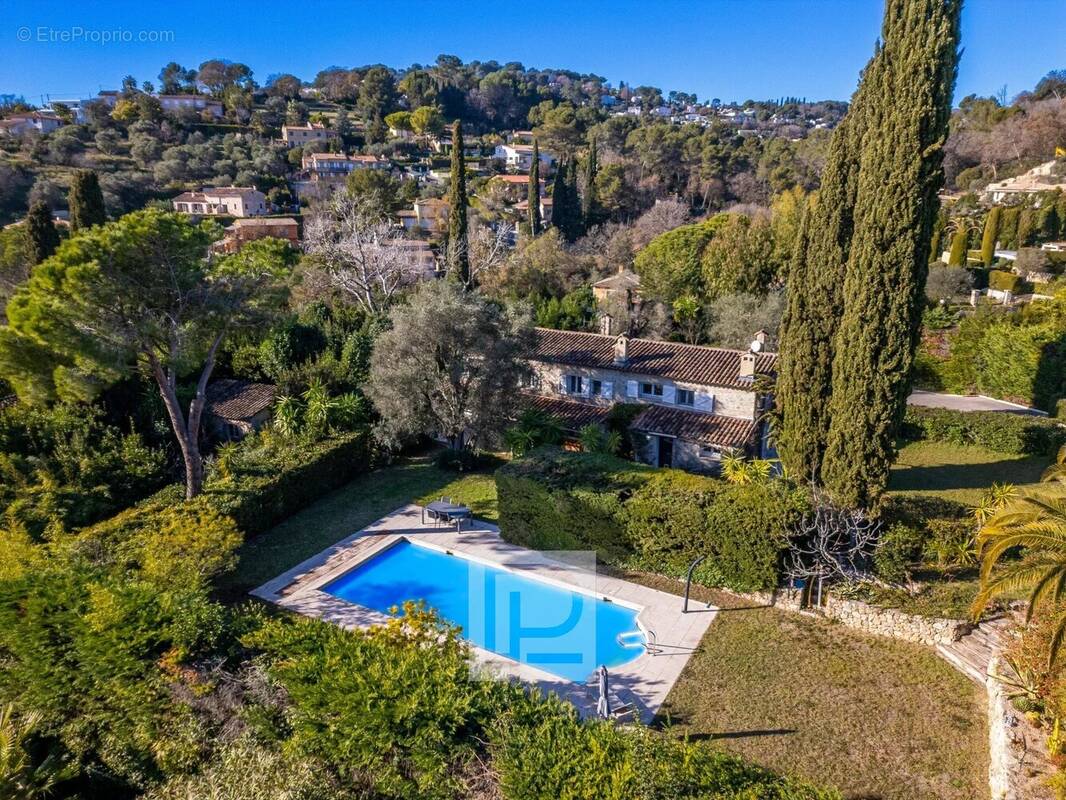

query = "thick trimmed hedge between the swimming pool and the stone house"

[{"left": 496, "top": 448, "right": 807, "bottom": 591}]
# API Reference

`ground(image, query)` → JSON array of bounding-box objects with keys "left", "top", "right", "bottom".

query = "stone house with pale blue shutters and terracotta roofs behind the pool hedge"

[{"left": 526, "top": 329, "right": 777, "bottom": 474}]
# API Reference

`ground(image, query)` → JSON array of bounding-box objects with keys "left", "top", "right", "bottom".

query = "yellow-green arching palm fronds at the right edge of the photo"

[{"left": 972, "top": 486, "right": 1066, "bottom": 666}]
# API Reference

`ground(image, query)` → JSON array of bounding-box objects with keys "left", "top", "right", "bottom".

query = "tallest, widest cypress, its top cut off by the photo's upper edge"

[{"left": 822, "top": 0, "right": 962, "bottom": 507}]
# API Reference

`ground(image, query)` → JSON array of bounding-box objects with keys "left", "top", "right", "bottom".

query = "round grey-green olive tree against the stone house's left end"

[{"left": 367, "top": 282, "right": 533, "bottom": 450}]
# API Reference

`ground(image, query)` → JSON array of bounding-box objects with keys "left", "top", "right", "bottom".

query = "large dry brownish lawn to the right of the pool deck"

[{"left": 627, "top": 575, "right": 988, "bottom": 800}]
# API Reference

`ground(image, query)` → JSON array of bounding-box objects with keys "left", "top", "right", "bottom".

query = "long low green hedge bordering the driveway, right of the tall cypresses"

[{"left": 903, "top": 406, "right": 1066, "bottom": 455}]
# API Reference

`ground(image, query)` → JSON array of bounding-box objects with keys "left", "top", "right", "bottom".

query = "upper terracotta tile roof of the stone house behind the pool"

[{"left": 533, "top": 327, "right": 777, "bottom": 389}]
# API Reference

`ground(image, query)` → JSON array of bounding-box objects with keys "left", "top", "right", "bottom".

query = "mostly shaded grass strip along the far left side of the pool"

[{"left": 220, "top": 455, "right": 502, "bottom": 599}]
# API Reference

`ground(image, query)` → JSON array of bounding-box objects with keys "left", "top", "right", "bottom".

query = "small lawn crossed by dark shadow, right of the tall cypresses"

[{"left": 888, "top": 442, "right": 1051, "bottom": 506}]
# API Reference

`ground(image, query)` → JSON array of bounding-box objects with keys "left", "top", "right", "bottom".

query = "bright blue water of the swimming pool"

[{"left": 322, "top": 540, "right": 643, "bottom": 682}]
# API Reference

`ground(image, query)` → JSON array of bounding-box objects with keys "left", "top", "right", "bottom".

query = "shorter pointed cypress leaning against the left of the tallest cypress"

[{"left": 776, "top": 81, "right": 877, "bottom": 482}]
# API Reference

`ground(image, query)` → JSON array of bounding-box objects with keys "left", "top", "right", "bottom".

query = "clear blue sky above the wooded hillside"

[{"left": 0, "top": 0, "right": 1066, "bottom": 102}]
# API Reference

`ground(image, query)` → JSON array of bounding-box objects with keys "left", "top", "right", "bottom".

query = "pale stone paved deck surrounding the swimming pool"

[{"left": 252, "top": 506, "right": 717, "bottom": 722}]
